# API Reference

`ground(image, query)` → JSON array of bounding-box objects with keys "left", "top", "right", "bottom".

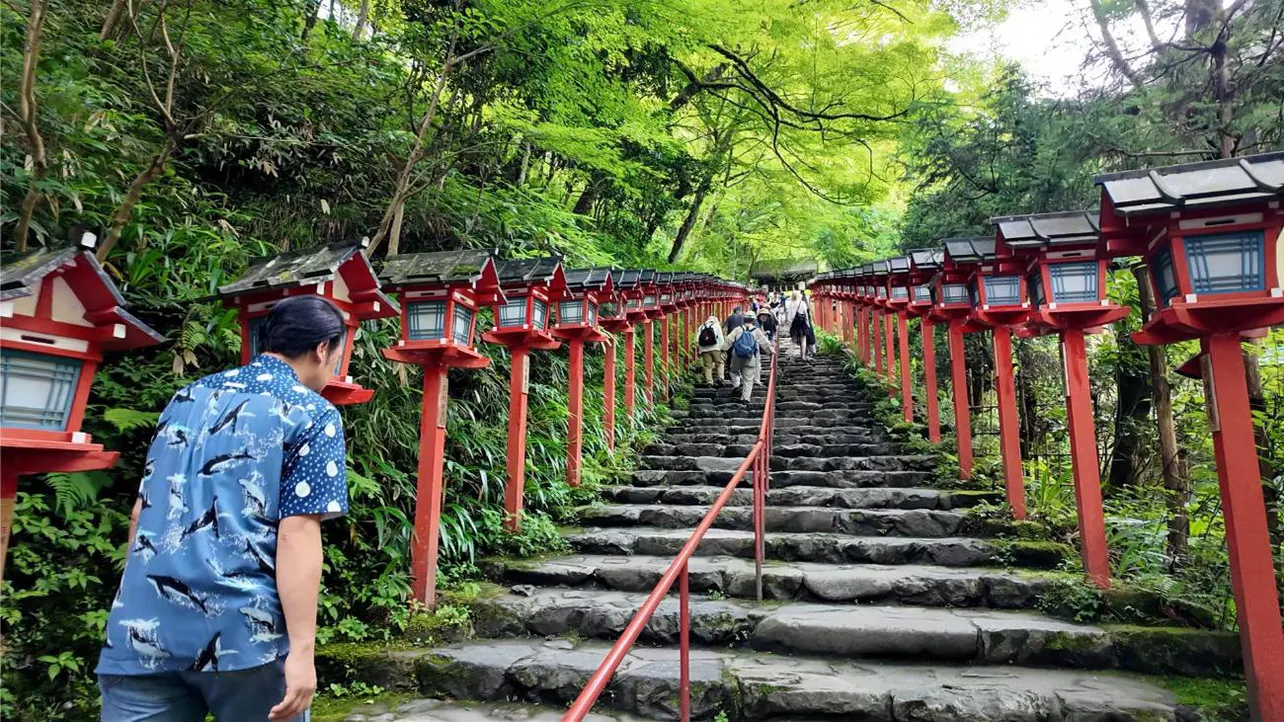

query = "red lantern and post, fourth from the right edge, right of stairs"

[{"left": 931, "top": 236, "right": 1011, "bottom": 479}]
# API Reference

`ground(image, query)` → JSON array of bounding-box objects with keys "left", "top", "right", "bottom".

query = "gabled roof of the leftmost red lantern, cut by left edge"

[{"left": 0, "top": 234, "right": 164, "bottom": 351}]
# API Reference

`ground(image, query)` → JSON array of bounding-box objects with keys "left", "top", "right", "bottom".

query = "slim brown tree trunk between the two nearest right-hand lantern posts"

[{"left": 1132, "top": 265, "right": 1190, "bottom": 569}]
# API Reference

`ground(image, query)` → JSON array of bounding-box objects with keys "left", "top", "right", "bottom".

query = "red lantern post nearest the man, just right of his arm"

[{"left": 410, "top": 364, "right": 449, "bottom": 609}]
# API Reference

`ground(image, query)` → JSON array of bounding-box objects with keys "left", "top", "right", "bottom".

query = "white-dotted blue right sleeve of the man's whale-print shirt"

[{"left": 280, "top": 406, "right": 348, "bottom": 519}]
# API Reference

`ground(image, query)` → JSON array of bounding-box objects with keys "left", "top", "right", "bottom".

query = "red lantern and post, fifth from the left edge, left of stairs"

[{"left": 553, "top": 269, "right": 612, "bottom": 487}]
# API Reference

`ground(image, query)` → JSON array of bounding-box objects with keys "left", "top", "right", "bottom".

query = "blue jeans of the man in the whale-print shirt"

[{"left": 98, "top": 656, "right": 308, "bottom": 722}]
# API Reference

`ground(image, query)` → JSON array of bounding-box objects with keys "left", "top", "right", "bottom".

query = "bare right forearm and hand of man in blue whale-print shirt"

[{"left": 268, "top": 514, "right": 321, "bottom": 719}]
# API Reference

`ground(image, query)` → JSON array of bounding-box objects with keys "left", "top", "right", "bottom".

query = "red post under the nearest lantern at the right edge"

[{"left": 1201, "top": 334, "right": 1284, "bottom": 722}]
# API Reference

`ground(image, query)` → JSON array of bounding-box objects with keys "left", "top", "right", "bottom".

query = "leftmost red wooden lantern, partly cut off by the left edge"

[{"left": 0, "top": 234, "right": 164, "bottom": 578}]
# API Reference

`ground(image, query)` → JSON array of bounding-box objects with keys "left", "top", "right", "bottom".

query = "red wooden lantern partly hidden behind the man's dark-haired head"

[{"left": 218, "top": 239, "right": 398, "bottom": 406}]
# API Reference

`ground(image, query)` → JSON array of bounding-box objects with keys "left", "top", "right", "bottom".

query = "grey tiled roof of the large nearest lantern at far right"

[{"left": 1093, "top": 152, "right": 1284, "bottom": 216}]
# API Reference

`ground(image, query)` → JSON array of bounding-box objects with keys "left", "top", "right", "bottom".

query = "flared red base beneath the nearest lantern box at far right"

[{"left": 1132, "top": 297, "right": 1284, "bottom": 346}]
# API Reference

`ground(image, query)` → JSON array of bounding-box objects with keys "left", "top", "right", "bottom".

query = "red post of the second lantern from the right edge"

[{"left": 1061, "top": 329, "right": 1111, "bottom": 588}]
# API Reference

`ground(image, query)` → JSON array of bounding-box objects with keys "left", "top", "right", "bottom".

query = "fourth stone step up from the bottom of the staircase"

[{"left": 566, "top": 527, "right": 1011, "bottom": 567}]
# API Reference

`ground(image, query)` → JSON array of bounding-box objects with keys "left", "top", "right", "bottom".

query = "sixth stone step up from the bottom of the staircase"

[{"left": 602, "top": 486, "right": 1003, "bottom": 510}]
